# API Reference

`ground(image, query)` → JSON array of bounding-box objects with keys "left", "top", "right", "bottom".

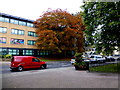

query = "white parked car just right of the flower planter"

[{"left": 88, "top": 55, "right": 105, "bottom": 63}]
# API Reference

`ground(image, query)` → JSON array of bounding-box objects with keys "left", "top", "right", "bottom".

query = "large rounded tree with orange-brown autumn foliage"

[{"left": 34, "top": 9, "right": 85, "bottom": 54}]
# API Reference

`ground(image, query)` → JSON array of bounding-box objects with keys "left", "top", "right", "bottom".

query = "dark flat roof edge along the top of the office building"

[{"left": 0, "top": 13, "right": 34, "bottom": 23}]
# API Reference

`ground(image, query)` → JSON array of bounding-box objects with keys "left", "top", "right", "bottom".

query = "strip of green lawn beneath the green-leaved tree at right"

[{"left": 90, "top": 63, "right": 120, "bottom": 73}]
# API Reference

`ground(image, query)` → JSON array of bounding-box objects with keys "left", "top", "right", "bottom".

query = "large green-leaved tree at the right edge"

[{"left": 82, "top": 2, "right": 120, "bottom": 55}]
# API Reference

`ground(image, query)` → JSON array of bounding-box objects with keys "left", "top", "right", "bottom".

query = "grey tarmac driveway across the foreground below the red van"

[{"left": 2, "top": 67, "right": 118, "bottom": 88}]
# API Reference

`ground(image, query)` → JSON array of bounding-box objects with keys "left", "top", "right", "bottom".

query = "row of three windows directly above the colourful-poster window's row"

[{"left": 0, "top": 27, "right": 37, "bottom": 37}]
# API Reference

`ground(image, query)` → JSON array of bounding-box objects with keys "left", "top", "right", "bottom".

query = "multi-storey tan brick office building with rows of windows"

[{"left": 0, "top": 13, "right": 50, "bottom": 56}]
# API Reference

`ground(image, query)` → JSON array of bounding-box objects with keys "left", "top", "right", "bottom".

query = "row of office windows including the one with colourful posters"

[{"left": 0, "top": 37, "right": 36, "bottom": 45}]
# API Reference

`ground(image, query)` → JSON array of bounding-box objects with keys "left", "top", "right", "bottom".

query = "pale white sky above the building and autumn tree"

[{"left": 0, "top": 0, "right": 83, "bottom": 20}]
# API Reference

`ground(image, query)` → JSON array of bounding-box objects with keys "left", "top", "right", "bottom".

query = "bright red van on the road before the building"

[{"left": 10, "top": 56, "right": 47, "bottom": 71}]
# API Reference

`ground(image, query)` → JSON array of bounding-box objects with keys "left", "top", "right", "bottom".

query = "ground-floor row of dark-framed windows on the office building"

[{"left": 0, "top": 48, "right": 51, "bottom": 55}]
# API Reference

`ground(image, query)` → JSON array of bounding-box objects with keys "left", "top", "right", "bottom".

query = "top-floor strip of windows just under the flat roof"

[{"left": 0, "top": 17, "right": 34, "bottom": 27}]
